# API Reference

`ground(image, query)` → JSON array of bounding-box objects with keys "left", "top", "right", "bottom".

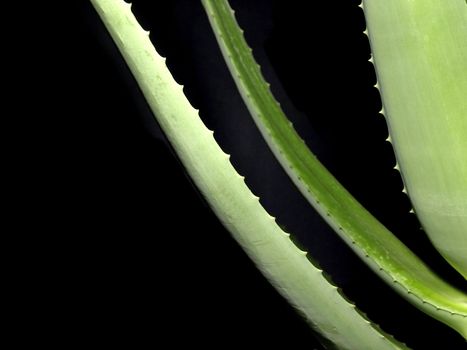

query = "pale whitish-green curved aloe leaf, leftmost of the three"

[{"left": 91, "top": 0, "right": 414, "bottom": 349}]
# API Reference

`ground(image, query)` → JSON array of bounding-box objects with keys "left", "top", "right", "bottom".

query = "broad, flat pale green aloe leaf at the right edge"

[{"left": 364, "top": 0, "right": 467, "bottom": 278}]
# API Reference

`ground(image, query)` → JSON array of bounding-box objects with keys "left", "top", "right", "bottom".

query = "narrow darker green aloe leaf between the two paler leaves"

[{"left": 202, "top": 0, "right": 467, "bottom": 337}]
